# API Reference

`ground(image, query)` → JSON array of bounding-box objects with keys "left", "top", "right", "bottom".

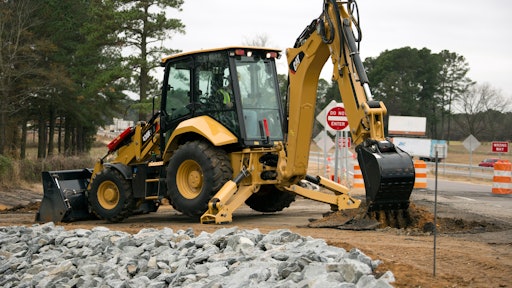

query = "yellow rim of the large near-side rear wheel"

[{"left": 176, "top": 160, "right": 203, "bottom": 199}]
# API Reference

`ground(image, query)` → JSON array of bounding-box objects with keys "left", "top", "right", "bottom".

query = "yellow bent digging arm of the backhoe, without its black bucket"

[{"left": 286, "top": 0, "right": 380, "bottom": 177}]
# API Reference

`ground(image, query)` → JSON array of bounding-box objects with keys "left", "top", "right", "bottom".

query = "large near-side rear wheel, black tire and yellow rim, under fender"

[{"left": 167, "top": 141, "right": 233, "bottom": 217}]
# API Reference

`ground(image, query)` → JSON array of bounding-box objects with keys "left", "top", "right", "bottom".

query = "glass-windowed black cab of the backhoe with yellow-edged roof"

[{"left": 161, "top": 47, "right": 283, "bottom": 149}]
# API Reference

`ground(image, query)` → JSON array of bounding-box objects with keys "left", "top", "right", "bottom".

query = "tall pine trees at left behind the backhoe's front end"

[{"left": 0, "top": 0, "right": 185, "bottom": 158}]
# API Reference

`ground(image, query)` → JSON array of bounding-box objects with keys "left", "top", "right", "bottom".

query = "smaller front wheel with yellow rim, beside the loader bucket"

[{"left": 88, "top": 168, "right": 137, "bottom": 222}]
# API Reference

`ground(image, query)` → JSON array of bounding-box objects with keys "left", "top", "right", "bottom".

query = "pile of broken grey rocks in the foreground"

[{"left": 0, "top": 223, "right": 394, "bottom": 288}]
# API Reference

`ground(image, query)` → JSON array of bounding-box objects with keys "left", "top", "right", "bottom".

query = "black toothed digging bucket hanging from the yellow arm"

[{"left": 356, "top": 141, "right": 415, "bottom": 211}]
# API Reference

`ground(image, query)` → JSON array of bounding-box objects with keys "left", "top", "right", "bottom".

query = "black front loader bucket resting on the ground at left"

[{"left": 36, "top": 169, "right": 93, "bottom": 222}]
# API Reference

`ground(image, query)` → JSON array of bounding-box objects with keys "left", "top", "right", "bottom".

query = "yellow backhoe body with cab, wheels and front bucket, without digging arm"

[{"left": 37, "top": 47, "right": 295, "bottom": 222}]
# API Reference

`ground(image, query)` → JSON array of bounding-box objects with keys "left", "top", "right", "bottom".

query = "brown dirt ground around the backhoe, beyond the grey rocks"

[{"left": 0, "top": 183, "right": 512, "bottom": 287}]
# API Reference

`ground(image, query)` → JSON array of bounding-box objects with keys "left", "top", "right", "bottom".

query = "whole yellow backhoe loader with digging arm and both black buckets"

[{"left": 36, "top": 0, "right": 415, "bottom": 223}]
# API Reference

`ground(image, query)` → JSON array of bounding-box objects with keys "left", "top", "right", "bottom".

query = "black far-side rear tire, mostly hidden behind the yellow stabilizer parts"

[{"left": 245, "top": 185, "right": 295, "bottom": 213}]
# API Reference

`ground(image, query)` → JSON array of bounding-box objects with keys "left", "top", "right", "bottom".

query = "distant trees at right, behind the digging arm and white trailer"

[{"left": 306, "top": 47, "right": 512, "bottom": 141}]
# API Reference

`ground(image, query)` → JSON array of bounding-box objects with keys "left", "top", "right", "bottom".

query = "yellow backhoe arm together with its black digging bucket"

[{"left": 280, "top": 0, "right": 414, "bottom": 209}]
